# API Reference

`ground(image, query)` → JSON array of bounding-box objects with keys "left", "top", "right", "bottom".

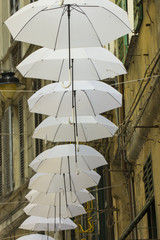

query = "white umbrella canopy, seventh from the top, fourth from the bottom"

[{"left": 25, "top": 189, "right": 95, "bottom": 206}]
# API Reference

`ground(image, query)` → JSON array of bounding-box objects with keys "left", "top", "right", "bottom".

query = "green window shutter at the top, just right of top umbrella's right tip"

[{"left": 134, "top": 0, "right": 143, "bottom": 33}]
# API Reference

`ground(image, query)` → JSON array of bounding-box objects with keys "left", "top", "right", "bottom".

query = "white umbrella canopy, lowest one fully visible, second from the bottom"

[{"left": 19, "top": 216, "right": 77, "bottom": 232}]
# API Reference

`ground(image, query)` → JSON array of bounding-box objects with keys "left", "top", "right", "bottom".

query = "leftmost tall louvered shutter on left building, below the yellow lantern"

[{"left": 3, "top": 107, "right": 13, "bottom": 194}]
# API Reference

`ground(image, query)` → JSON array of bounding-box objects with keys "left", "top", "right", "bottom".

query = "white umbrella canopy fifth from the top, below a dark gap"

[{"left": 29, "top": 144, "right": 107, "bottom": 174}]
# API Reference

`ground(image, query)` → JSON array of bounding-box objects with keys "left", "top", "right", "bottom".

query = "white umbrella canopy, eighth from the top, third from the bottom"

[{"left": 23, "top": 203, "right": 86, "bottom": 218}]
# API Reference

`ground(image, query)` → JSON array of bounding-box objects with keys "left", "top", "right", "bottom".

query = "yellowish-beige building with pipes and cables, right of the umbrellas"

[{"left": 109, "top": 0, "right": 160, "bottom": 240}]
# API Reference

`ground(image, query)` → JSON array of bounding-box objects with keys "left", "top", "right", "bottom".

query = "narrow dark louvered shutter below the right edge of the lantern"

[{"left": 18, "top": 98, "right": 25, "bottom": 183}]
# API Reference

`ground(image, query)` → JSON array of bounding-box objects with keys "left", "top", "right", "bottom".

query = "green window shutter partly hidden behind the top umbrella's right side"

[{"left": 116, "top": 0, "right": 128, "bottom": 63}]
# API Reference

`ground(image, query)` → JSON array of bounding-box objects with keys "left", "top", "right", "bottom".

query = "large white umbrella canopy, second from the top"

[{"left": 17, "top": 47, "right": 127, "bottom": 82}]
